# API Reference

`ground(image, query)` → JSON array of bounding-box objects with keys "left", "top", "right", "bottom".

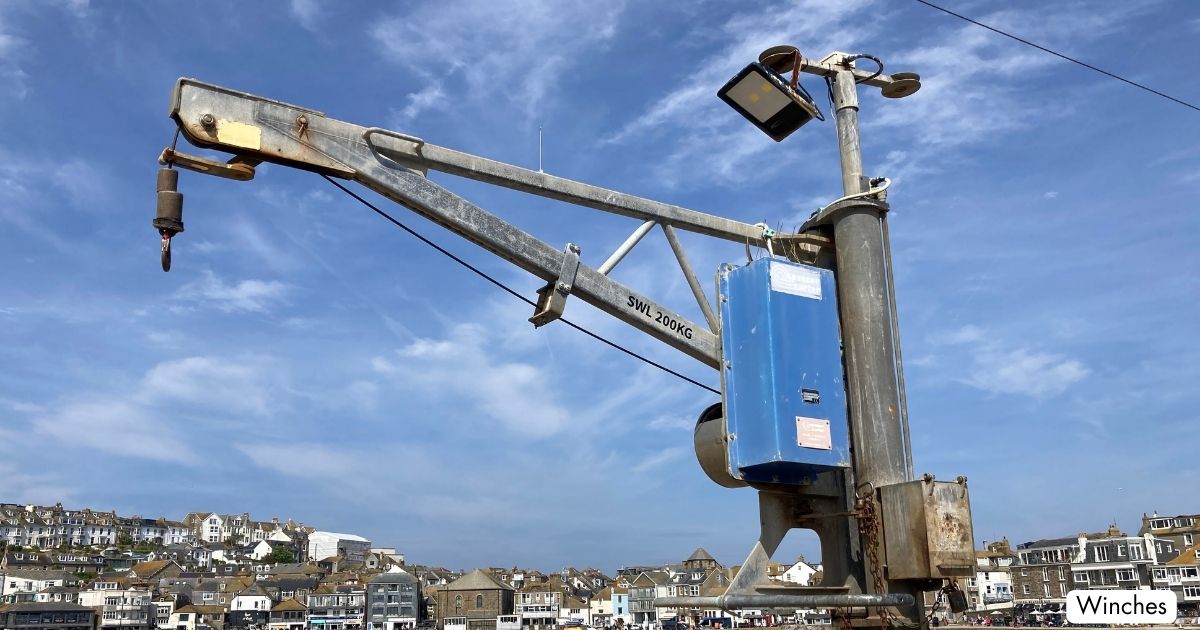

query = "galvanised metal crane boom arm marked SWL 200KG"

[{"left": 170, "top": 78, "right": 739, "bottom": 368}]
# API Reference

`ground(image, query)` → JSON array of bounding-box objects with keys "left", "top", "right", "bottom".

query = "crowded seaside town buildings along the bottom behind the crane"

[{"left": 7, "top": 503, "right": 1200, "bottom": 630}]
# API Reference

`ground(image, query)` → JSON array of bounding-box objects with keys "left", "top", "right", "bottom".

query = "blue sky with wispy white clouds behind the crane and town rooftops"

[{"left": 0, "top": 0, "right": 1200, "bottom": 570}]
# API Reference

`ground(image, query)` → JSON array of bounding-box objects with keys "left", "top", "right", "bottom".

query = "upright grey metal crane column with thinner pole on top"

[{"left": 833, "top": 71, "right": 923, "bottom": 623}]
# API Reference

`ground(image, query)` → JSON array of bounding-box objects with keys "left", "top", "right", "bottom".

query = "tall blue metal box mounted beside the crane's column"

[{"left": 718, "top": 258, "right": 850, "bottom": 484}]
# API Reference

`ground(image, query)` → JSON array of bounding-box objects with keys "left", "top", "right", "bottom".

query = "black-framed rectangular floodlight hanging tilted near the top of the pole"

[{"left": 716, "top": 61, "right": 821, "bottom": 142}]
